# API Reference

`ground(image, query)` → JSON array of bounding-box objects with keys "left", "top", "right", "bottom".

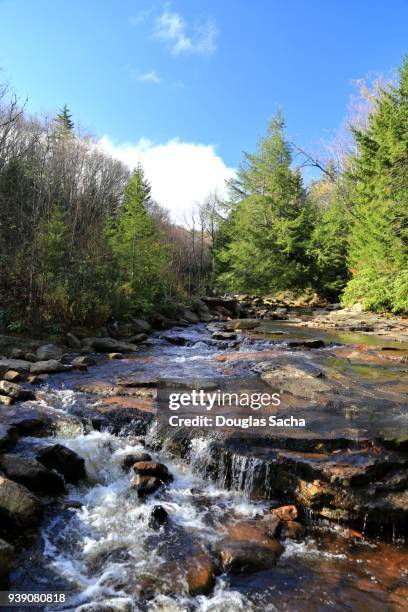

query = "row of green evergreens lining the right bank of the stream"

[{"left": 216, "top": 58, "right": 408, "bottom": 313}]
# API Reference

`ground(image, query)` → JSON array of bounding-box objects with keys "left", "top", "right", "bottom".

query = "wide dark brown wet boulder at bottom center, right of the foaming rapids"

[{"left": 219, "top": 540, "right": 283, "bottom": 574}]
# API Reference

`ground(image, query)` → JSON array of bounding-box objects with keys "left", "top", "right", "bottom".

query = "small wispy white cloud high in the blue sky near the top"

[{"left": 154, "top": 10, "right": 219, "bottom": 55}]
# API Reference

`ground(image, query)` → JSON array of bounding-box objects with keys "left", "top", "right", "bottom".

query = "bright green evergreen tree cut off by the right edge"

[{"left": 343, "top": 58, "right": 408, "bottom": 312}]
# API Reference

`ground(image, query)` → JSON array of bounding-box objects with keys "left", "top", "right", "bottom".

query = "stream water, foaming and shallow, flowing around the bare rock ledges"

[{"left": 7, "top": 321, "right": 408, "bottom": 612}]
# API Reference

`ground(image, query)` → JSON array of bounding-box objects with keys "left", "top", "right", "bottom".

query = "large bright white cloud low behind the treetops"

[{"left": 99, "top": 136, "right": 235, "bottom": 222}]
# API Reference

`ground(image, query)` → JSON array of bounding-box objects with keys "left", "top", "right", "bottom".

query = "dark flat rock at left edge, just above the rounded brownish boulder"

[{"left": 0, "top": 453, "right": 65, "bottom": 495}]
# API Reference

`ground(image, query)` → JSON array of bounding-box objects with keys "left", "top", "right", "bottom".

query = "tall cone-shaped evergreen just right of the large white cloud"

[{"left": 217, "top": 113, "right": 314, "bottom": 291}]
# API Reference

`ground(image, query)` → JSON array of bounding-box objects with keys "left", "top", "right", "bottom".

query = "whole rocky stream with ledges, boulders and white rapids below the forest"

[{"left": 0, "top": 301, "right": 408, "bottom": 612}]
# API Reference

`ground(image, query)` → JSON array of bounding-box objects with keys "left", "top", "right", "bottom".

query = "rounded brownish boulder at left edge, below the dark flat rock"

[{"left": 0, "top": 476, "right": 42, "bottom": 528}]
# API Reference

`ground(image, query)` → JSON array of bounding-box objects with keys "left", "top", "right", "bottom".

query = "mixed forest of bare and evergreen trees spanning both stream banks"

[{"left": 0, "top": 58, "right": 408, "bottom": 332}]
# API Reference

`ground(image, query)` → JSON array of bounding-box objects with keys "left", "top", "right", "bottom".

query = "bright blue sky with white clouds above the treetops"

[{"left": 0, "top": 0, "right": 408, "bottom": 218}]
